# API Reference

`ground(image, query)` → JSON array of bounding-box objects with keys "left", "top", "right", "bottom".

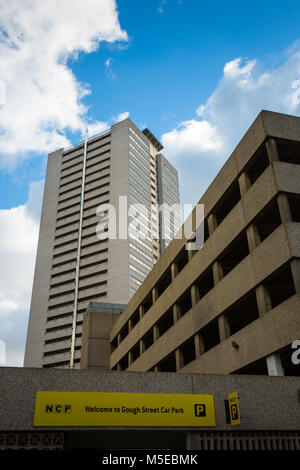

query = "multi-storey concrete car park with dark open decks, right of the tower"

[{"left": 82, "top": 111, "right": 300, "bottom": 376}]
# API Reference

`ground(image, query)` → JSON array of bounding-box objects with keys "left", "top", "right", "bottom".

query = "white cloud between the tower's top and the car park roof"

[{"left": 161, "top": 43, "right": 300, "bottom": 203}]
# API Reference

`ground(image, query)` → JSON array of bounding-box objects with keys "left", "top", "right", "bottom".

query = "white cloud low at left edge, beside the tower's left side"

[{"left": 0, "top": 182, "right": 43, "bottom": 366}]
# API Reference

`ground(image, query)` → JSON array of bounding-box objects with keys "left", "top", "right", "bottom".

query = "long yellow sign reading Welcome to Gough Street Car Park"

[{"left": 33, "top": 392, "right": 216, "bottom": 427}]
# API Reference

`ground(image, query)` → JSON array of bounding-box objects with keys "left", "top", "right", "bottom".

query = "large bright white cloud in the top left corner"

[{"left": 0, "top": 0, "right": 127, "bottom": 167}]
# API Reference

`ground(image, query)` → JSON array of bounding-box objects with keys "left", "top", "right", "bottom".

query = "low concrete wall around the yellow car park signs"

[{"left": 0, "top": 367, "right": 300, "bottom": 431}]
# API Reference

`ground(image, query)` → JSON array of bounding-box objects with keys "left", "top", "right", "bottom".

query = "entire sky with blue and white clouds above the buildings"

[{"left": 0, "top": 0, "right": 300, "bottom": 365}]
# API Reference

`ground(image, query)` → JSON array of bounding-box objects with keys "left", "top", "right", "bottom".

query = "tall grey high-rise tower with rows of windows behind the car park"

[{"left": 24, "top": 119, "right": 179, "bottom": 368}]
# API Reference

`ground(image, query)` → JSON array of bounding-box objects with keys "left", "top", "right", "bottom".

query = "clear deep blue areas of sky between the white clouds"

[{"left": 0, "top": 0, "right": 300, "bottom": 209}]
